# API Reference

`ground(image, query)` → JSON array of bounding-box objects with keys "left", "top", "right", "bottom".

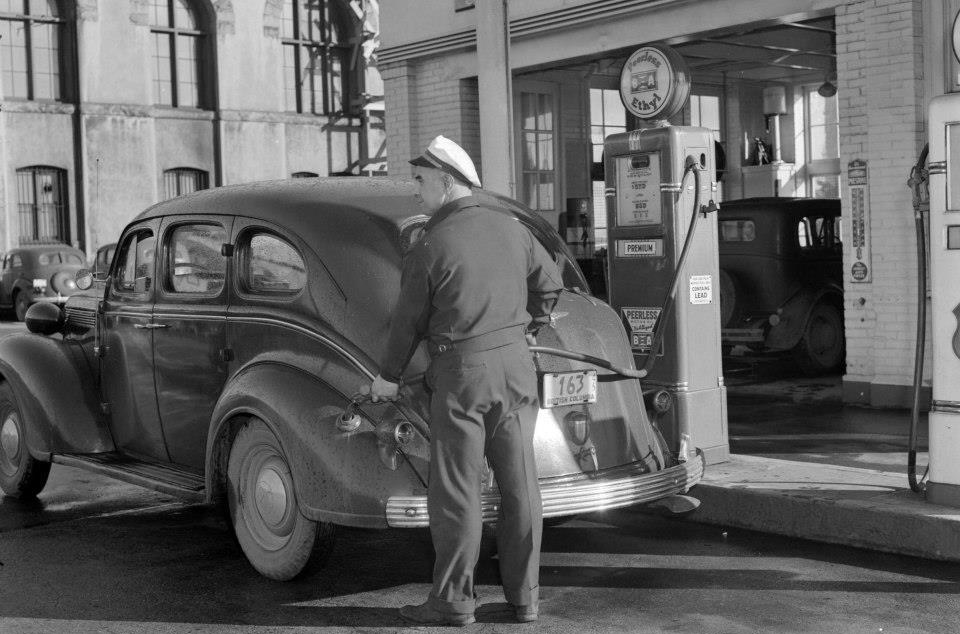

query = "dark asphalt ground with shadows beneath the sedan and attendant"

[{"left": 0, "top": 466, "right": 960, "bottom": 634}]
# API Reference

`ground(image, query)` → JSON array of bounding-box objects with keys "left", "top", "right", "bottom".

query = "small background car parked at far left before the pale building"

[{"left": 0, "top": 243, "right": 86, "bottom": 321}]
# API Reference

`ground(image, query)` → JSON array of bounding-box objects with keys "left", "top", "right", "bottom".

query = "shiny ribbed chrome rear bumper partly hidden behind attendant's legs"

[{"left": 386, "top": 451, "right": 704, "bottom": 528}]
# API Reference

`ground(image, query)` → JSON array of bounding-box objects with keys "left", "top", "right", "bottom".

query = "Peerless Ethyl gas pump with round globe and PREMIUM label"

[{"left": 604, "top": 46, "right": 729, "bottom": 464}]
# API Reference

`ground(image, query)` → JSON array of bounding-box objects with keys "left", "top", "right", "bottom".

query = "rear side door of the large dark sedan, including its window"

[{"left": 153, "top": 216, "right": 233, "bottom": 470}]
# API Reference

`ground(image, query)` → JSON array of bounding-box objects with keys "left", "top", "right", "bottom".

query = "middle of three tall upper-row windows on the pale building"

[{"left": 150, "top": 0, "right": 207, "bottom": 108}]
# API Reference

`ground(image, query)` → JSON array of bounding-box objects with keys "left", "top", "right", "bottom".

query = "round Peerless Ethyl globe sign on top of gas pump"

[{"left": 620, "top": 45, "right": 690, "bottom": 119}]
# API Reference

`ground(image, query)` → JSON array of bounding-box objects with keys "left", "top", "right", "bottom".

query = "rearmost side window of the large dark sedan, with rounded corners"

[{"left": 240, "top": 232, "right": 307, "bottom": 295}]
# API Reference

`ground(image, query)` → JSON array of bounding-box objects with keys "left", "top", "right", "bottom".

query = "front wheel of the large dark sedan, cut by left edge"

[{"left": 0, "top": 383, "right": 50, "bottom": 498}]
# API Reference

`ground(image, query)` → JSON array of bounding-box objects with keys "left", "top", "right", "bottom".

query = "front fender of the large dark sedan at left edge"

[{"left": 0, "top": 334, "right": 114, "bottom": 461}]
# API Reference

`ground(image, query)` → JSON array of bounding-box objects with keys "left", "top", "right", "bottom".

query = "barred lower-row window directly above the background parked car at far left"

[{"left": 17, "top": 165, "right": 70, "bottom": 244}]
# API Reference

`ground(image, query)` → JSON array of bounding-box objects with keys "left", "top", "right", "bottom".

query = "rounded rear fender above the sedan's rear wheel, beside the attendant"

[{"left": 206, "top": 362, "right": 428, "bottom": 528}]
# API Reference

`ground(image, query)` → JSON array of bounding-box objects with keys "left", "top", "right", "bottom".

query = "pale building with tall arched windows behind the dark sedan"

[{"left": 0, "top": 0, "right": 386, "bottom": 252}]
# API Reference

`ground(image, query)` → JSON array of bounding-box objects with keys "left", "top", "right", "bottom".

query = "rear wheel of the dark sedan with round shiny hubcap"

[{"left": 227, "top": 419, "right": 334, "bottom": 581}]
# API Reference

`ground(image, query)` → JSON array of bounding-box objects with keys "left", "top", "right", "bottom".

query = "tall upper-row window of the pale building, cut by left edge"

[{"left": 0, "top": 0, "right": 64, "bottom": 101}]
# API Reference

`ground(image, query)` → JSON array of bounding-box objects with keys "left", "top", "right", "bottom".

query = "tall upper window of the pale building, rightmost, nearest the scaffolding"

[{"left": 280, "top": 0, "right": 354, "bottom": 115}]
